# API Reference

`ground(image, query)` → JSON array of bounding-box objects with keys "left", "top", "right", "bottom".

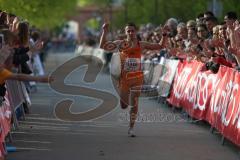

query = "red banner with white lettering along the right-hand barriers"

[{"left": 168, "top": 61, "right": 240, "bottom": 146}]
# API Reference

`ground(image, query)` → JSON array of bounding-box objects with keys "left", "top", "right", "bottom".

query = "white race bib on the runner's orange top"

[{"left": 124, "top": 58, "right": 140, "bottom": 72}]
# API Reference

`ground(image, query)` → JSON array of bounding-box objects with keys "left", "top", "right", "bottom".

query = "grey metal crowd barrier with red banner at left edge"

[{"left": 0, "top": 80, "right": 28, "bottom": 158}]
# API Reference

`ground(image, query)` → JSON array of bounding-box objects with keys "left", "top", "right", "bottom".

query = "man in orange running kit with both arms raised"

[{"left": 100, "top": 23, "right": 166, "bottom": 137}]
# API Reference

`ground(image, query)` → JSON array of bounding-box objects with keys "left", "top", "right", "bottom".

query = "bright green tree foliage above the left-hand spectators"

[{"left": 0, "top": 0, "right": 77, "bottom": 29}]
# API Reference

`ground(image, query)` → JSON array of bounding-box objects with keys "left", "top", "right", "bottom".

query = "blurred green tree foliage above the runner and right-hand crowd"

[{"left": 112, "top": 0, "right": 208, "bottom": 28}]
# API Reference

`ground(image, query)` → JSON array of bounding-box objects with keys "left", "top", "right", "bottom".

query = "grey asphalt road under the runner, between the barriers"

[{"left": 7, "top": 54, "right": 240, "bottom": 160}]
